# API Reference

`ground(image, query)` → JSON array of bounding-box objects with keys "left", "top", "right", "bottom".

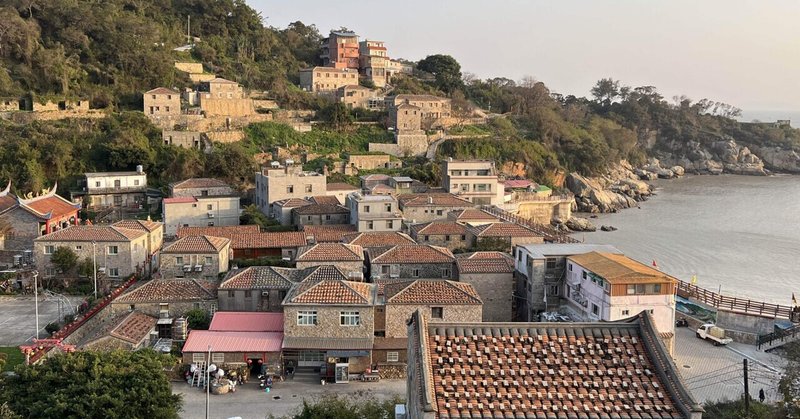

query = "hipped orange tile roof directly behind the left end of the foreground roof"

[{"left": 383, "top": 279, "right": 483, "bottom": 304}]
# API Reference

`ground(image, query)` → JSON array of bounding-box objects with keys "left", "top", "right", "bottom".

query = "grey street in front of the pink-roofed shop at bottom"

[{"left": 172, "top": 379, "right": 406, "bottom": 419}]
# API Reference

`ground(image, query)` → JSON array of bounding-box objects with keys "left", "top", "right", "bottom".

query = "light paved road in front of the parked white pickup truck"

[{"left": 675, "top": 328, "right": 785, "bottom": 403}]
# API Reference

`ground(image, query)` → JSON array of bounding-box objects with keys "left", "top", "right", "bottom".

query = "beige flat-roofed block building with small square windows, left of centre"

[{"left": 256, "top": 164, "right": 327, "bottom": 216}]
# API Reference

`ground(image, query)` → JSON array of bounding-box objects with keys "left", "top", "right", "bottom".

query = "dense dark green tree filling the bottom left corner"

[{"left": 0, "top": 349, "right": 181, "bottom": 418}]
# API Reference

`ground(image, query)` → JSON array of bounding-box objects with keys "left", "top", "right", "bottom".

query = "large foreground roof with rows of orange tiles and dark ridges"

[{"left": 408, "top": 311, "right": 702, "bottom": 418}]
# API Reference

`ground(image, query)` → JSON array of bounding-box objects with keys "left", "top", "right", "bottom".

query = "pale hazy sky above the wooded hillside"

[{"left": 253, "top": 0, "right": 800, "bottom": 112}]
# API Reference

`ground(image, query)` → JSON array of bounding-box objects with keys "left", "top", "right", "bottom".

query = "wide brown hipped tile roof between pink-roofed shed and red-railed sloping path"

[{"left": 114, "top": 279, "right": 216, "bottom": 303}]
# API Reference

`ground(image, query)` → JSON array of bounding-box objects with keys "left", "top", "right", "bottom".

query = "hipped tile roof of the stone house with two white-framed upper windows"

[{"left": 285, "top": 279, "right": 375, "bottom": 305}]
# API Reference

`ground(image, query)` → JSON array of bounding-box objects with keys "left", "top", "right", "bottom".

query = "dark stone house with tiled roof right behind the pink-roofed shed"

[{"left": 217, "top": 266, "right": 300, "bottom": 312}]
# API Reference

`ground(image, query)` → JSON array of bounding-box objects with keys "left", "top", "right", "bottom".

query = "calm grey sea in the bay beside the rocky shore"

[{"left": 574, "top": 175, "right": 800, "bottom": 305}]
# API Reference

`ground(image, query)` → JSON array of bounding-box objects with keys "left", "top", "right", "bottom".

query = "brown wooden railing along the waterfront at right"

[{"left": 678, "top": 280, "right": 792, "bottom": 319}]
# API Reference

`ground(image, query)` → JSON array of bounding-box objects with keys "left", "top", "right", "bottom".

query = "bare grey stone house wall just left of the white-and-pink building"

[{"left": 458, "top": 272, "right": 514, "bottom": 322}]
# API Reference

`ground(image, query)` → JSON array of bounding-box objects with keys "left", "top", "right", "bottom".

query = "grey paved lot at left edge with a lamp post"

[{"left": 0, "top": 294, "right": 82, "bottom": 346}]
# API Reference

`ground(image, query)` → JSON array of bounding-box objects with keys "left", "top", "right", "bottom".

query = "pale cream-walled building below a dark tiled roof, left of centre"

[{"left": 162, "top": 195, "right": 240, "bottom": 237}]
